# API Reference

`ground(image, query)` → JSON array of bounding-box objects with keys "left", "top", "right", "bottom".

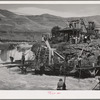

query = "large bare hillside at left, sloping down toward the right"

[{"left": 0, "top": 10, "right": 49, "bottom": 32}]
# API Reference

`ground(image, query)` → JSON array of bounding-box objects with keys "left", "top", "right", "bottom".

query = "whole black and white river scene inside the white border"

[{"left": 0, "top": 4, "right": 100, "bottom": 91}]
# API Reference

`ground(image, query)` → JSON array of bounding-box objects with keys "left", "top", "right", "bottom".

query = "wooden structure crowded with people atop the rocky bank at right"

[{"left": 56, "top": 19, "right": 99, "bottom": 43}]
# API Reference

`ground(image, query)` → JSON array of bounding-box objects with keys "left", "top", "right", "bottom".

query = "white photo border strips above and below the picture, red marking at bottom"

[{"left": 0, "top": 1, "right": 100, "bottom": 99}]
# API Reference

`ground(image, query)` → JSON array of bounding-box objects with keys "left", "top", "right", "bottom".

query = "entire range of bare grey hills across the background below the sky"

[{"left": 0, "top": 9, "right": 100, "bottom": 39}]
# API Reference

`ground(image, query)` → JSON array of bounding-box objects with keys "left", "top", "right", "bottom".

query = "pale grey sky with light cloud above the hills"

[{"left": 0, "top": 4, "right": 100, "bottom": 17}]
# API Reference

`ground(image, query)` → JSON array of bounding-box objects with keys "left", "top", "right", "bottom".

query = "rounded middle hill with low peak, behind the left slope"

[{"left": 27, "top": 14, "right": 67, "bottom": 29}]
